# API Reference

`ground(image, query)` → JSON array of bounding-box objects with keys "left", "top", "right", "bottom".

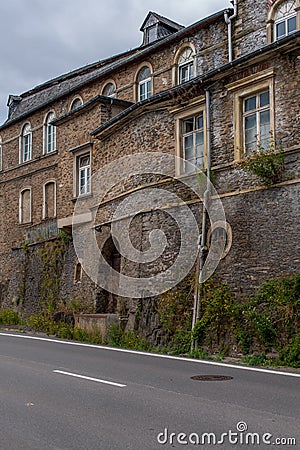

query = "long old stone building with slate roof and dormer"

[{"left": 0, "top": 0, "right": 300, "bottom": 342}]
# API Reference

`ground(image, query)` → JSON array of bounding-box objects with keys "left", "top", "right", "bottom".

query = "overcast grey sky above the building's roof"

[{"left": 0, "top": 0, "right": 231, "bottom": 123}]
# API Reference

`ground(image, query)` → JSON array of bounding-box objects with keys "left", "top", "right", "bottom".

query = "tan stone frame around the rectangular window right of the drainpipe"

[{"left": 227, "top": 68, "right": 275, "bottom": 161}]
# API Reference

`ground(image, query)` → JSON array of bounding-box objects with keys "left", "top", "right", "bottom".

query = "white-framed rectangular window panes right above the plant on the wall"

[{"left": 243, "top": 89, "right": 271, "bottom": 155}]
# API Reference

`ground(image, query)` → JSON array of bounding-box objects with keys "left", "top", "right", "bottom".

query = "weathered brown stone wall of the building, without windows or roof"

[{"left": 0, "top": 0, "right": 300, "bottom": 343}]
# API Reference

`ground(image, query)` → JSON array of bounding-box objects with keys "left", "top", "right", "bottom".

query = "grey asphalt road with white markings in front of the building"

[{"left": 0, "top": 332, "right": 300, "bottom": 450}]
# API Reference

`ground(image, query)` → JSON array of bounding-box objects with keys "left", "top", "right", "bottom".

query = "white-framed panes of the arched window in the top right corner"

[{"left": 274, "top": 0, "right": 297, "bottom": 40}]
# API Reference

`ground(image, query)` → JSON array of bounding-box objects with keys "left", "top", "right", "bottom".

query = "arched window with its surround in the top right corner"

[{"left": 267, "top": 0, "right": 300, "bottom": 43}]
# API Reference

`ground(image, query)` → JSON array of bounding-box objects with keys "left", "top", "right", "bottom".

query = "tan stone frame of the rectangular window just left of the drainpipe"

[{"left": 172, "top": 97, "right": 207, "bottom": 176}]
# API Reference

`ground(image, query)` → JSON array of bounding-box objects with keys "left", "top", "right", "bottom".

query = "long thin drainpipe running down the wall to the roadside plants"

[{"left": 191, "top": 89, "right": 211, "bottom": 350}]
